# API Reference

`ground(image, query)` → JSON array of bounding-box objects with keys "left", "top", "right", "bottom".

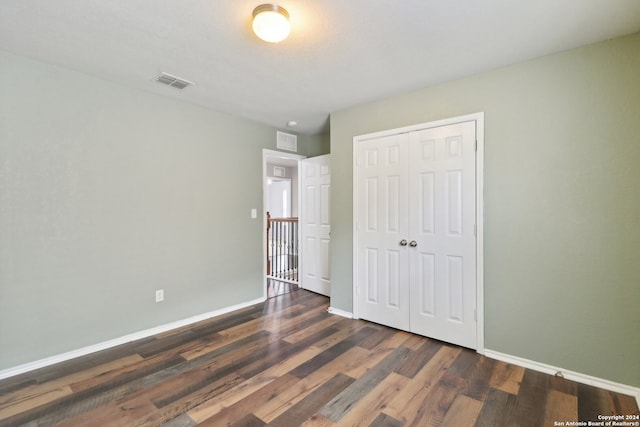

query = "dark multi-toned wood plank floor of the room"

[{"left": 0, "top": 290, "right": 640, "bottom": 427}]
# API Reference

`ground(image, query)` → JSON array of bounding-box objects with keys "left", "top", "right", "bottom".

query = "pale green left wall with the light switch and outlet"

[{"left": 0, "top": 52, "right": 328, "bottom": 370}]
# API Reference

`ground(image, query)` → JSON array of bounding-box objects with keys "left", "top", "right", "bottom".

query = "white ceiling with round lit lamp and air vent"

[{"left": 0, "top": 0, "right": 640, "bottom": 134}]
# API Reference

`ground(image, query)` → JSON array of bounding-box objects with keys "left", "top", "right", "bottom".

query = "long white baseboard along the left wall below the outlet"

[{"left": 0, "top": 298, "right": 266, "bottom": 380}]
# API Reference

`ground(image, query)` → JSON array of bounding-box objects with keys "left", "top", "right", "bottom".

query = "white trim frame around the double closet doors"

[{"left": 352, "top": 112, "right": 484, "bottom": 354}]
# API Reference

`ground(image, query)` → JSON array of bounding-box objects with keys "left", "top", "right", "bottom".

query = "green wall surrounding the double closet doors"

[{"left": 331, "top": 34, "right": 640, "bottom": 387}]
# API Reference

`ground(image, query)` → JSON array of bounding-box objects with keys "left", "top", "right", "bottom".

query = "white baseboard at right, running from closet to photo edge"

[{"left": 484, "top": 349, "right": 640, "bottom": 407}]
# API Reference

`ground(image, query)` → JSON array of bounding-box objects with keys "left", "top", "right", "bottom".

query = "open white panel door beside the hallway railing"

[{"left": 299, "top": 154, "right": 331, "bottom": 296}]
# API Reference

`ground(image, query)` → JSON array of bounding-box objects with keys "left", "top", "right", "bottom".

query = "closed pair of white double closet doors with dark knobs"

[{"left": 354, "top": 114, "right": 482, "bottom": 348}]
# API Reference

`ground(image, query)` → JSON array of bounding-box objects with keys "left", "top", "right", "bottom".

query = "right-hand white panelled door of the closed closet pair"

[{"left": 409, "top": 122, "right": 476, "bottom": 348}]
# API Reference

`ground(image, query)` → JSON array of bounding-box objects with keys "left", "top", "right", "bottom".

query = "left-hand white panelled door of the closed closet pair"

[{"left": 356, "top": 134, "right": 409, "bottom": 330}]
